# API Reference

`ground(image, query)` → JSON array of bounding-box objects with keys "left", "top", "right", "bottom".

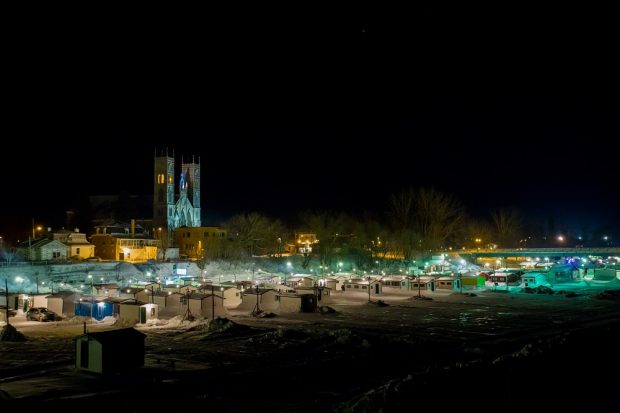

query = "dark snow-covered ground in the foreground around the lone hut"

[{"left": 0, "top": 290, "right": 620, "bottom": 411}]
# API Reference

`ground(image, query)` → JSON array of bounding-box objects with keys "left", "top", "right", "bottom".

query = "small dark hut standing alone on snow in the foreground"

[{"left": 75, "top": 328, "right": 146, "bottom": 374}]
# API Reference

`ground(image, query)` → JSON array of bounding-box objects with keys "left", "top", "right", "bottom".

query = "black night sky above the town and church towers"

[{"left": 0, "top": 7, "right": 620, "bottom": 241}]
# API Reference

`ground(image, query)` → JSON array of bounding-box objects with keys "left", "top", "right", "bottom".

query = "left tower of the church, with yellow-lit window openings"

[{"left": 153, "top": 149, "right": 175, "bottom": 246}]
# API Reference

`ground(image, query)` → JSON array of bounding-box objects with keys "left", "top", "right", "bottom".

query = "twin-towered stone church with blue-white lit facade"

[{"left": 153, "top": 150, "right": 200, "bottom": 247}]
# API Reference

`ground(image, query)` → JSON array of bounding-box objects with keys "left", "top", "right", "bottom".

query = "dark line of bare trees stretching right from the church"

[{"left": 204, "top": 188, "right": 611, "bottom": 269}]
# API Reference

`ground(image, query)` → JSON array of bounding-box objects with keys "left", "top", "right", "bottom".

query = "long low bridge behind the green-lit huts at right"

[{"left": 446, "top": 247, "right": 620, "bottom": 260}]
